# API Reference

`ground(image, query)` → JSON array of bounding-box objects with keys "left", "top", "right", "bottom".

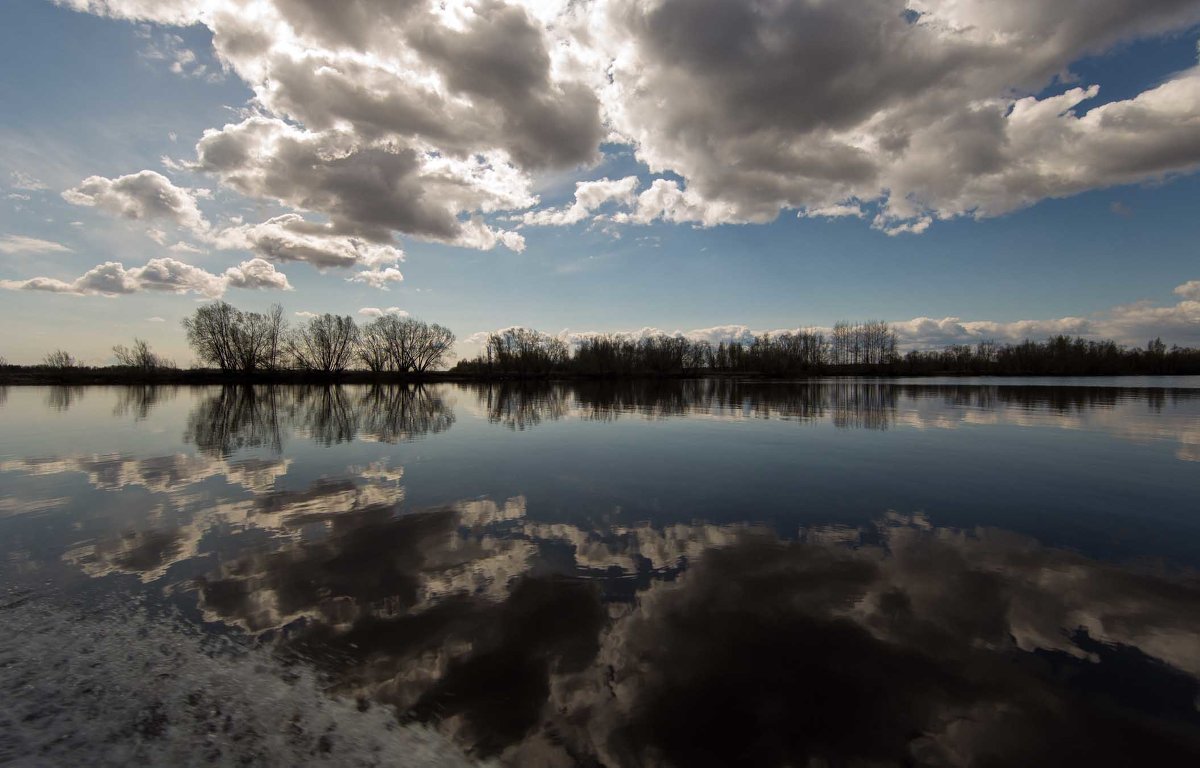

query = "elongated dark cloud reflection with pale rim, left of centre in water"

[{"left": 200, "top": 494, "right": 533, "bottom": 631}]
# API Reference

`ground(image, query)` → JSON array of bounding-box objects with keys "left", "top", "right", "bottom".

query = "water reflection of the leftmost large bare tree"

[{"left": 184, "top": 386, "right": 283, "bottom": 456}]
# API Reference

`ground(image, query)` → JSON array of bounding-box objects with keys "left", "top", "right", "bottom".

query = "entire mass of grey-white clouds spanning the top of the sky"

[{"left": 60, "top": 0, "right": 1200, "bottom": 238}]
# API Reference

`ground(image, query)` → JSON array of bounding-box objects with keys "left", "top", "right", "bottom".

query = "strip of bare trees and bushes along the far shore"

[{"left": 0, "top": 301, "right": 1200, "bottom": 385}]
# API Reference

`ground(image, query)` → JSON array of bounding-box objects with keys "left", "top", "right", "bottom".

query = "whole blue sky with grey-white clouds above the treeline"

[{"left": 0, "top": 0, "right": 1200, "bottom": 365}]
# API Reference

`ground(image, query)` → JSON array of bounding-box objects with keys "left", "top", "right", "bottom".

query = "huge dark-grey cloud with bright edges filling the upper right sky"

[{"left": 594, "top": 0, "right": 1200, "bottom": 232}]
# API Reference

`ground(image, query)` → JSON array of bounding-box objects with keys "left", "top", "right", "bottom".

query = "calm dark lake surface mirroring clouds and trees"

[{"left": 0, "top": 377, "right": 1200, "bottom": 766}]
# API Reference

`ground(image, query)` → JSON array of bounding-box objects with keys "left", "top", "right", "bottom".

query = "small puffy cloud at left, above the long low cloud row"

[{"left": 62, "top": 170, "right": 209, "bottom": 233}]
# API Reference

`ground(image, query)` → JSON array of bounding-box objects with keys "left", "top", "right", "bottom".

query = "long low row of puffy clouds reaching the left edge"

[{"left": 0, "top": 258, "right": 292, "bottom": 298}]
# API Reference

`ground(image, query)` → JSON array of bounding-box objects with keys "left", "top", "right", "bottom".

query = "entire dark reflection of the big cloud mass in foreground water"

[{"left": 182, "top": 482, "right": 1200, "bottom": 766}]
